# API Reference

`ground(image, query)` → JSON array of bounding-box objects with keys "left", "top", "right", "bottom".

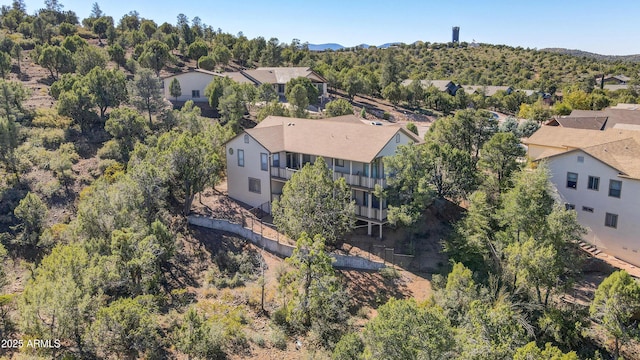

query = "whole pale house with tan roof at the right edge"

[{"left": 525, "top": 126, "right": 640, "bottom": 266}]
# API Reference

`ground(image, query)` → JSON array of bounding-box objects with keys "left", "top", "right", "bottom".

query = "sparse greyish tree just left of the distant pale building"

[{"left": 129, "top": 69, "right": 164, "bottom": 128}]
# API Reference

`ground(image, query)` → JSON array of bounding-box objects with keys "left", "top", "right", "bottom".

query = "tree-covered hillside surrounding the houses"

[{"left": 0, "top": 0, "right": 640, "bottom": 360}]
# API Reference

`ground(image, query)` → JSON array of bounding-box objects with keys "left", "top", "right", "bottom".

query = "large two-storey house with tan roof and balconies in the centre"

[{"left": 225, "top": 115, "right": 420, "bottom": 238}]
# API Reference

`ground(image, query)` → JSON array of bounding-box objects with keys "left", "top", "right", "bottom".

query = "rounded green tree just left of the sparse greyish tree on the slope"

[{"left": 84, "top": 67, "right": 127, "bottom": 119}]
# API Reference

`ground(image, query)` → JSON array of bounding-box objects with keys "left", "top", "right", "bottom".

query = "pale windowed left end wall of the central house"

[{"left": 225, "top": 133, "right": 271, "bottom": 206}]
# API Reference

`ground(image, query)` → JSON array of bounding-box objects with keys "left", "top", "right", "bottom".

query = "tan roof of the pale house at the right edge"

[{"left": 525, "top": 126, "right": 640, "bottom": 179}]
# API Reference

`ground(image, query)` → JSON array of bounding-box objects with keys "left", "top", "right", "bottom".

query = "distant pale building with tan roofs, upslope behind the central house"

[{"left": 162, "top": 67, "right": 328, "bottom": 102}]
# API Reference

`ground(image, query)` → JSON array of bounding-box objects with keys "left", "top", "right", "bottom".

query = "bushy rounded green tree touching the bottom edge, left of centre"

[{"left": 91, "top": 296, "right": 160, "bottom": 359}]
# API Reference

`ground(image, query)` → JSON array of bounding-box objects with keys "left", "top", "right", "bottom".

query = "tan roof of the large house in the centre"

[{"left": 245, "top": 115, "right": 420, "bottom": 163}]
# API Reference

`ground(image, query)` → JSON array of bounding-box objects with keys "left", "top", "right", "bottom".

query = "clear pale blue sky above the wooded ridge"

[{"left": 12, "top": 0, "right": 640, "bottom": 55}]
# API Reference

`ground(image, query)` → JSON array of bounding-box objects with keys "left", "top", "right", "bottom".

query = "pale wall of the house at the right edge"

[{"left": 548, "top": 151, "right": 640, "bottom": 266}]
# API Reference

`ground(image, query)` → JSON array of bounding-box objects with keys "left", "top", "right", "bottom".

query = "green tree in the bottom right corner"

[{"left": 589, "top": 270, "right": 640, "bottom": 359}]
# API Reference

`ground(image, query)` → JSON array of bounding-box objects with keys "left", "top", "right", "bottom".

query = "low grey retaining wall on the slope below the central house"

[{"left": 188, "top": 215, "right": 385, "bottom": 270}]
